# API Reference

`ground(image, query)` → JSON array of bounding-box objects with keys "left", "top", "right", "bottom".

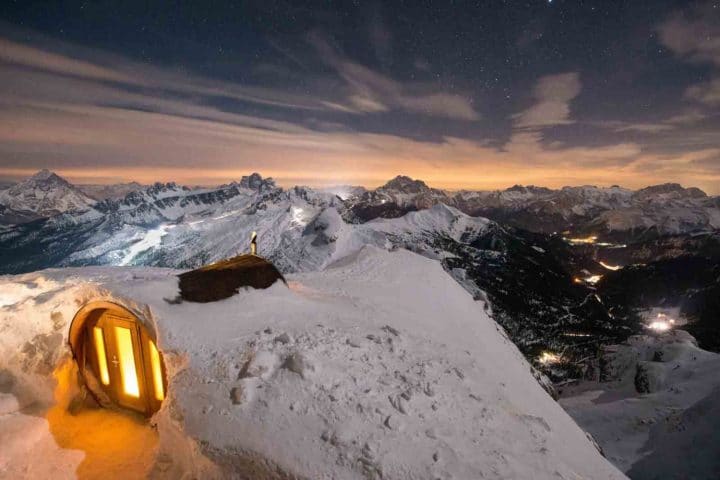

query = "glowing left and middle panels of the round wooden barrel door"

[{"left": 88, "top": 310, "right": 148, "bottom": 412}]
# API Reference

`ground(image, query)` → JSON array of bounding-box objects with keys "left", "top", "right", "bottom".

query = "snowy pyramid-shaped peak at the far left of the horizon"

[{"left": 0, "top": 170, "right": 95, "bottom": 221}]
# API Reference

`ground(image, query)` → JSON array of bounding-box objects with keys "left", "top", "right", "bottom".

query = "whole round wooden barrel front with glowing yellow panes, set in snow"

[{"left": 70, "top": 302, "right": 167, "bottom": 416}]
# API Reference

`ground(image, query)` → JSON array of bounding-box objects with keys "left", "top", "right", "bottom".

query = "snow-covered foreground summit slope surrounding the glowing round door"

[{"left": 0, "top": 248, "right": 624, "bottom": 479}]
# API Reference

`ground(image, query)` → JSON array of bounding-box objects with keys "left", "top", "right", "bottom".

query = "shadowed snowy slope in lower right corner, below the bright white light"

[{"left": 560, "top": 330, "right": 720, "bottom": 479}]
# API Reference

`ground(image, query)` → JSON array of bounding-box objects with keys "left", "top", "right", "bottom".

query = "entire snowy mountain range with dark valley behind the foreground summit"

[{"left": 0, "top": 171, "right": 720, "bottom": 378}]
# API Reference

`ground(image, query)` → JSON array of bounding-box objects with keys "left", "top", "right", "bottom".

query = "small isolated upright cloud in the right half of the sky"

[{"left": 513, "top": 72, "right": 581, "bottom": 128}]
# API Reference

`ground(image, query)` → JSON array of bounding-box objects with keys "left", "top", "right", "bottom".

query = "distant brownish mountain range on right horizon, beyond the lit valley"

[{"left": 348, "top": 176, "right": 720, "bottom": 241}]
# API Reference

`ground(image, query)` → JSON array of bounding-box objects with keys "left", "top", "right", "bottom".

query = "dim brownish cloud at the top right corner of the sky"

[{"left": 657, "top": 2, "right": 720, "bottom": 106}]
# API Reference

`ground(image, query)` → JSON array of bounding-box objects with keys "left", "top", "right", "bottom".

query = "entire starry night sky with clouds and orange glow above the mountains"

[{"left": 0, "top": 0, "right": 720, "bottom": 194}]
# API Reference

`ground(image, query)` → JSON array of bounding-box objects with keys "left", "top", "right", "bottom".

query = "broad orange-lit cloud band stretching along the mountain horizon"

[{"left": 0, "top": 99, "right": 720, "bottom": 191}]
